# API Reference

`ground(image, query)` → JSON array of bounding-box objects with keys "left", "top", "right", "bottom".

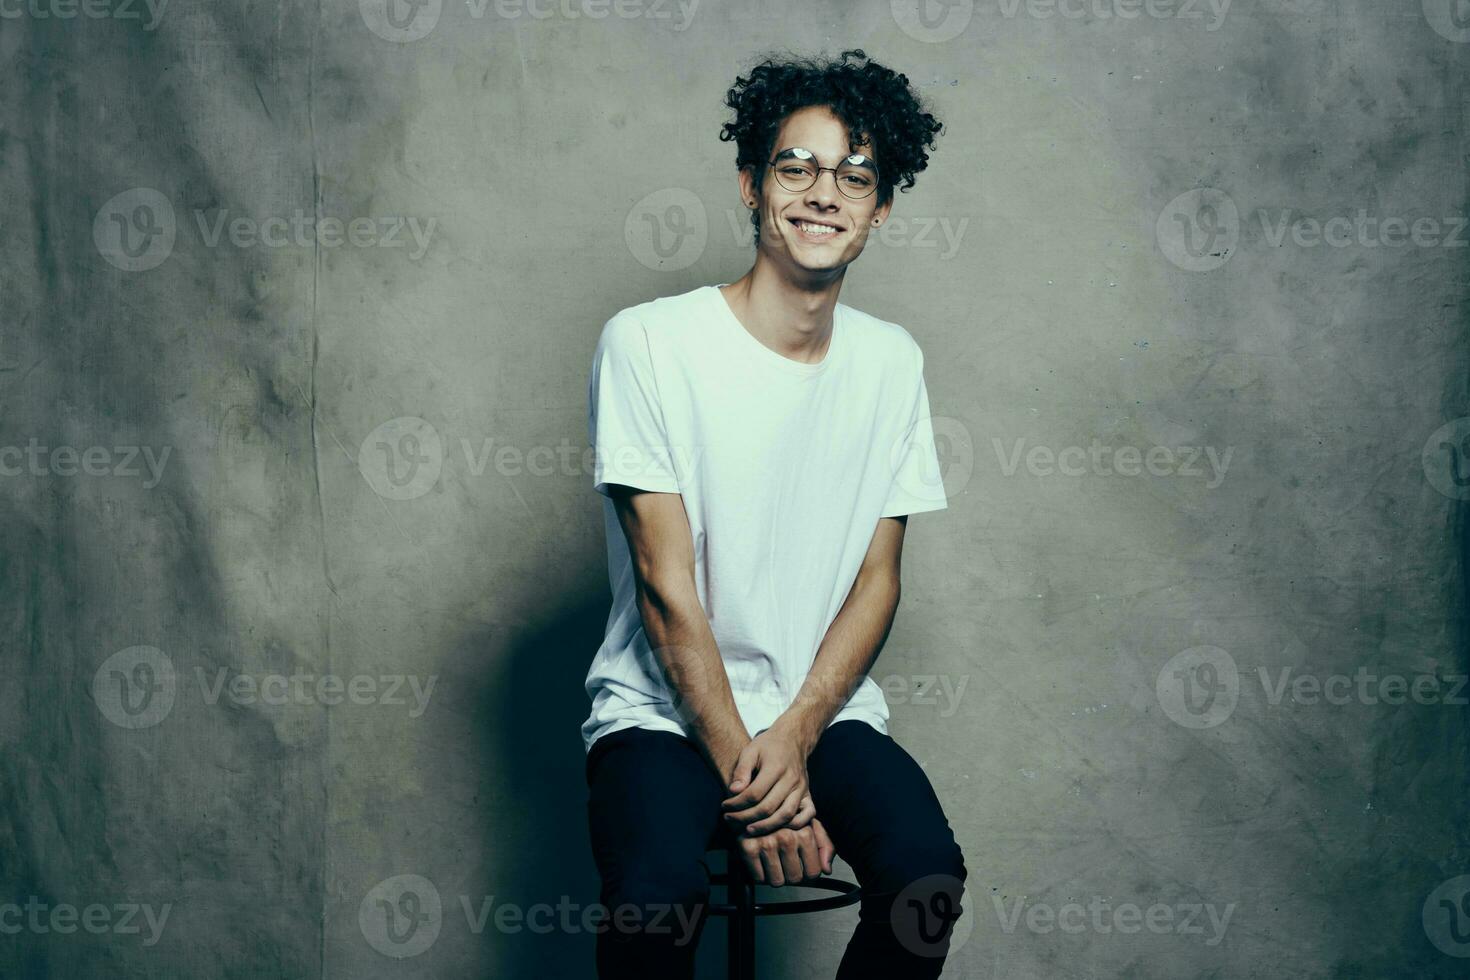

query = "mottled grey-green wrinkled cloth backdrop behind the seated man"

[{"left": 0, "top": 0, "right": 1470, "bottom": 979}]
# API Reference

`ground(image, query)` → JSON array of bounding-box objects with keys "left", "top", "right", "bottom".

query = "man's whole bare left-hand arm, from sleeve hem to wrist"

[{"left": 609, "top": 483, "right": 750, "bottom": 786}]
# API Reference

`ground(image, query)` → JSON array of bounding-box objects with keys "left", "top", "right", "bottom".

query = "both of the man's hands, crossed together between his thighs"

[{"left": 722, "top": 727, "right": 836, "bottom": 887}]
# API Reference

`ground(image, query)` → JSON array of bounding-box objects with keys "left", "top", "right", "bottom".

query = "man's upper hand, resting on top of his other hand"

[{"left": 723, "top": 726, "right": 816, "bottom": 837}]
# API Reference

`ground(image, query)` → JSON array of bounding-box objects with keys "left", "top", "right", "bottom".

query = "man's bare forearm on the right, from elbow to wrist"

[{"left": 772, "top": 572, "right": 900, "bottom": 755}]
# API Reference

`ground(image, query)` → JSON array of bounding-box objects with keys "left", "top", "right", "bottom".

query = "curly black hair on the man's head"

[{"left": 720, "top": 48, "right": 944, "bottom": 242}]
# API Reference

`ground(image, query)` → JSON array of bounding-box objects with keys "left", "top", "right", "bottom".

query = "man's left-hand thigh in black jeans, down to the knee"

[{"left": 587, "top": 727, "right": 726, "bottom": 893}]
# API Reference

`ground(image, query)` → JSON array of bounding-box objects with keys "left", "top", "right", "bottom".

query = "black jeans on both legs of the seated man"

[{"left": 587, "top": 720, "right": 966, "bottom": 980}]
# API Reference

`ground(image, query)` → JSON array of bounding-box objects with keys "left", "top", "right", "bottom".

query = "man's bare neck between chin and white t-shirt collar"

[{"left": 720, "top": 259, "right": 847, "bottom": 364}]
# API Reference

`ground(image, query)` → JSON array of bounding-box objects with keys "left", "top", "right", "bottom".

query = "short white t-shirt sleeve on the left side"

[{"left": 587, "top": 314, "right": 679, "bottom": 497}]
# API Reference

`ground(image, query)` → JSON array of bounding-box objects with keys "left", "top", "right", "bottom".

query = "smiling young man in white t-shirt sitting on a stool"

[{"left": 582, "top": 51, "right": 966, "bottom": 980}]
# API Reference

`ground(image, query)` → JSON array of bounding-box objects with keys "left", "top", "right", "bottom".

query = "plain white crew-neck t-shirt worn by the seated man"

[{"left": 582, "top": 284, "right": 947, "bottom": 751}]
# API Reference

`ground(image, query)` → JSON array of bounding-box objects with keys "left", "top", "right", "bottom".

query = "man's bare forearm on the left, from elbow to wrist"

[{"left": 638, "top": 582, "right": 750, "bottom": 782}]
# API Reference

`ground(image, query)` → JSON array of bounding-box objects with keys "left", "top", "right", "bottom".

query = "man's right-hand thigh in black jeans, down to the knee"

[{"left": 807, "top": 720, "right": 966, "bottom": 892}]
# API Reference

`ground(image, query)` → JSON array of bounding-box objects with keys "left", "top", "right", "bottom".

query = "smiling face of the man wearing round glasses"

[{"left": 741, "top": 106, "right": 891, "bottom": 272}]
